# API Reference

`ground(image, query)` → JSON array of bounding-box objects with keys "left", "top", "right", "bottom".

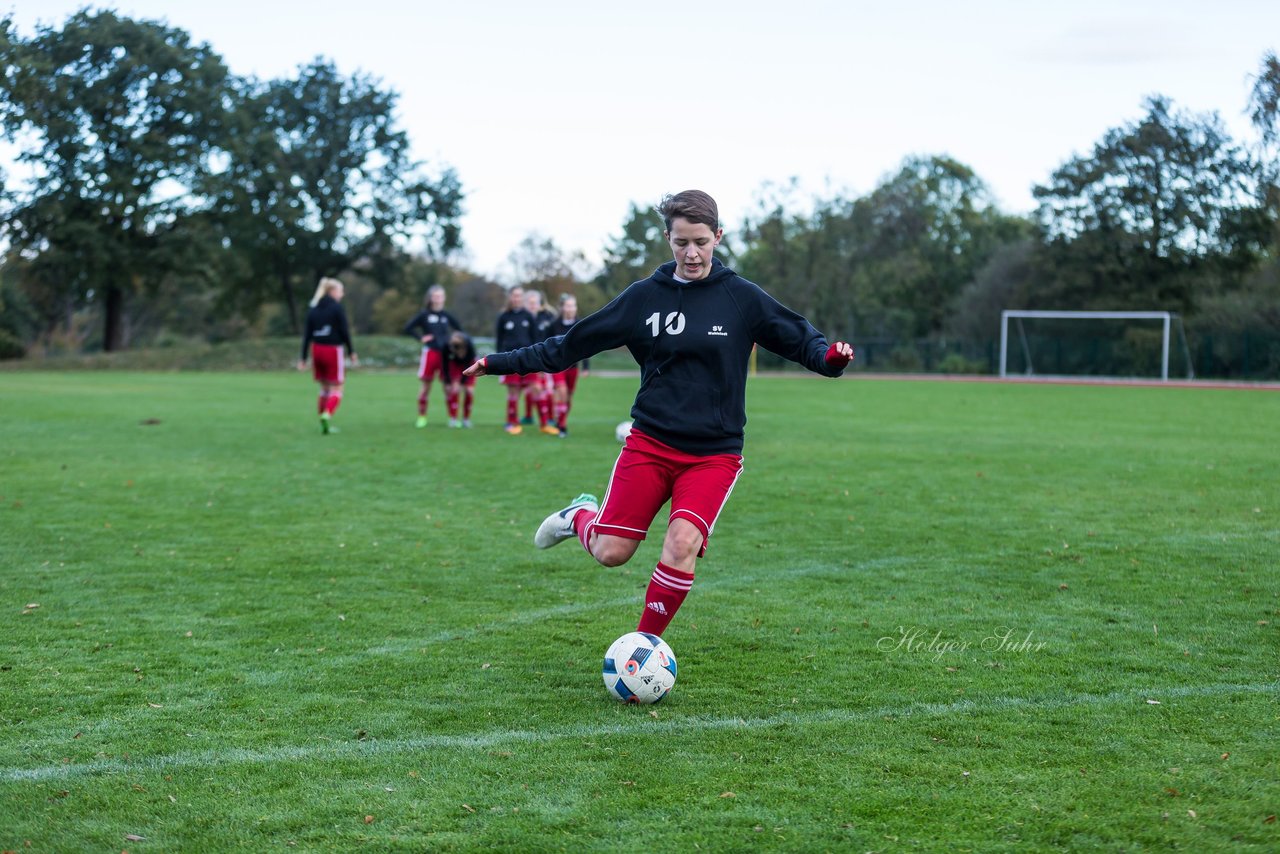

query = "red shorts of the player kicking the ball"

[{"left": 588, "top": 430, "right": 742, "bottom": 557}]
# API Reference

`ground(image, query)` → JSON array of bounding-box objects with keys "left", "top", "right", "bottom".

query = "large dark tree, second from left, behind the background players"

[{"left": 216, "top": 59, "right": 463, "bottom": 330}]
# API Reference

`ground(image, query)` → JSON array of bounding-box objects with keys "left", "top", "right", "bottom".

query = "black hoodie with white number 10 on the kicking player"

[{"left": 485, "top": 260, "right": 844, "bottom": 456}]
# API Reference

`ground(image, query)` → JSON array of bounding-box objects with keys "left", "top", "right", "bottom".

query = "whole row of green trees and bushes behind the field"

[{"left": 0, "top": 10, "right": 1280, "bottom": 374}]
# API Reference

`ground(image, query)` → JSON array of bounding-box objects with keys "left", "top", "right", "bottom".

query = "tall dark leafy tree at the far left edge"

[{"left": 0, "top": 12, "right": 228, "bottom": 351}]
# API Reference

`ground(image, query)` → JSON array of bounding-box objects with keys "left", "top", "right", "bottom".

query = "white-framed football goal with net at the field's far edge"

[{"left": 1000, "top": 309, "right": 1193, "bottom": 380}]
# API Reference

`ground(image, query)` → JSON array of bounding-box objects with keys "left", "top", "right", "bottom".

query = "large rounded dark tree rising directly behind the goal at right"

[{"left": 1033, "top": 96, "right": 1251, "bottom": 311}]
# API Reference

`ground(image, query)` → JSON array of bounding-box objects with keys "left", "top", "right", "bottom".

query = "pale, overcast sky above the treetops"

[{"left": 0, "top": 0, "right": 1280, "bottom": 280}]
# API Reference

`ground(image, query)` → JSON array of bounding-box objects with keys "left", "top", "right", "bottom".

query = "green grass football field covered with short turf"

[{"left": 0, "top": 371, "right": 1280, "bottom": 851}]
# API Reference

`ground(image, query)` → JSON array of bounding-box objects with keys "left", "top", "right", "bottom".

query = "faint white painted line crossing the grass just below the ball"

[{"left": 0, "top": 682, "right": 1280, "bottom": 782}]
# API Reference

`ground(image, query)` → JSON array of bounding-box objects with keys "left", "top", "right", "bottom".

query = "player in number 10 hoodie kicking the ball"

[{"left": 467, "top": 189, "right": 854, "bottom": 635}]
